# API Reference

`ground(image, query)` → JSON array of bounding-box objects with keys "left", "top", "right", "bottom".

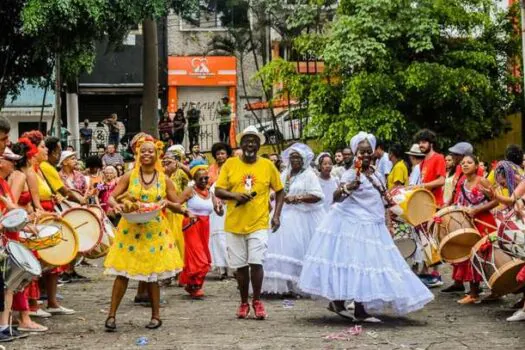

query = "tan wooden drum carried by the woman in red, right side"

[{"left": 430, "top": 206, "right": 481, "bottom": 264}]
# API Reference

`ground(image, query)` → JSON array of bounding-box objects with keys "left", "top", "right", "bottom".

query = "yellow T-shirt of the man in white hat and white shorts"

[{"left": 215, "top": 157, "right": 283, "bottom": 234}]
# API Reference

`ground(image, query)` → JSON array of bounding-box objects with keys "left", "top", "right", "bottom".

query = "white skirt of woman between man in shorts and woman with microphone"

[{"left": 262, "top": 204, "right": 325, "bottom": 294}]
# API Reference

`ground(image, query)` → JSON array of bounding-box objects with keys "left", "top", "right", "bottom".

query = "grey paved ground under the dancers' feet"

[{"left": 6, "top": 261, "right": 525, "bottom": 350}]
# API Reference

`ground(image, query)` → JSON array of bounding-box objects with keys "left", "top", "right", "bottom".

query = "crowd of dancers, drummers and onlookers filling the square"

[{"left": 0, "top": 117, "right": 525, "bottom": 341}]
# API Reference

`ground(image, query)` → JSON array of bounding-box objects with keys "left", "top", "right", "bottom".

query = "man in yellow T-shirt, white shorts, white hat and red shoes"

[{"left": 215, "top": 126, "right": 284, "bottom": 320}]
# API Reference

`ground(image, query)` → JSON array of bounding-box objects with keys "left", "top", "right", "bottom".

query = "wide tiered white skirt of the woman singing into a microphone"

[{"left": 299, "top": 208, "right": 434, "bottom": 315}]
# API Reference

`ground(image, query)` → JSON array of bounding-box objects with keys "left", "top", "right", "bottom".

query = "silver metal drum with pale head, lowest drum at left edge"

[{"left": 4, "top": 241, "right": 42, "bottom": 292}]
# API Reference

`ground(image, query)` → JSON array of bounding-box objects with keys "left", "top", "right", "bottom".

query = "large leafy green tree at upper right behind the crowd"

[{"left": 302, "top": 0, "right": 521, "bottom": 146}]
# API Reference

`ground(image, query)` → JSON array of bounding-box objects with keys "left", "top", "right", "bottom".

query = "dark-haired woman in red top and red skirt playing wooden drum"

[{"left": 447, "top": 154, "right": 498, "bottom": 305}]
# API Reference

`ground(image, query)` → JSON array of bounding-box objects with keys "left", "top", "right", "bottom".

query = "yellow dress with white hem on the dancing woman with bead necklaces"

[{"left": 104, "top": 169, "right": 183, "bottom": 282}]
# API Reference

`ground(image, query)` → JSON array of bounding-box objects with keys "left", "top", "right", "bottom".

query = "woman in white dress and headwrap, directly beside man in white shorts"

[{"left": 263, "top": 143, "right": 325, "bottom": 294}]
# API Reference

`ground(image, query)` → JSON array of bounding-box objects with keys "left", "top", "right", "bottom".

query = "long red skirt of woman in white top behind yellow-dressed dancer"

[{"left": 179, "top": 216, "right": 211, "bottom": 287}]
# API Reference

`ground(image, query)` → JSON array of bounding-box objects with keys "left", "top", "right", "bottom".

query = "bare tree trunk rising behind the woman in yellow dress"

[{"left": 140, "top": 19, "right": 159, "bottom": 137}]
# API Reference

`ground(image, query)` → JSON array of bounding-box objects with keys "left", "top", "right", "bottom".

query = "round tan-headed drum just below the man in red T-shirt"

[{"left": 389, "top": 187, "right": 436, "bottom": 226}]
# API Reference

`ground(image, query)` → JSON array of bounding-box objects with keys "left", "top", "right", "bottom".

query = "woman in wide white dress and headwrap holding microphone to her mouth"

[{"left": 299, "top": 132, "right": 434, "bottom": 322}]
